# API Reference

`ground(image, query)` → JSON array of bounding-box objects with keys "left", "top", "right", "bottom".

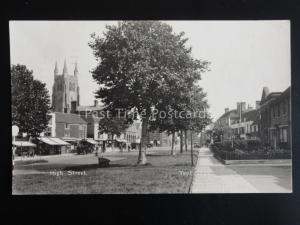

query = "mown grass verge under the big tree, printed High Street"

[{"left": 12, "top": 151, "right": 197, "bottom": 194}]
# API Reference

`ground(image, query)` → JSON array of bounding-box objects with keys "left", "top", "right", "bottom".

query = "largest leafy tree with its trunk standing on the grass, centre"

[{"left": 89, "top": 21, "right": 207, "bottom": 164}]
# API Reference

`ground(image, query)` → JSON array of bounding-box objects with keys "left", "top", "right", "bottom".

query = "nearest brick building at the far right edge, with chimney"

[{"left": 260, "top": 87, "right": 291, "bottom": 149}]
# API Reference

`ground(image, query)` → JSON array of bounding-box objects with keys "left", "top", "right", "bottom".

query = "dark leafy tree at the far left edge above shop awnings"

[{"left": 11, "top": 64, "right": 50, "bottom": 137}]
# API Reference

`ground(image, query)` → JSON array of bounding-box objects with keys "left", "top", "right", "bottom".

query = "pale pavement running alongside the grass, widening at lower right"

[{"left": 190, "top": 148, "right": 292, "bottom": 193}]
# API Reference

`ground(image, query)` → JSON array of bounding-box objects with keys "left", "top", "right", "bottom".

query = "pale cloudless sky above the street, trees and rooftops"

[{"left": 9, "top": 20, "right": 291, "bottom": 119}]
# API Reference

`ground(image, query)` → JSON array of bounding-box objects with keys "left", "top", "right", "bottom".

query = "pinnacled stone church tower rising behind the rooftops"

[{"left": 52, "top": 60, "right": 80, "bottom": 113}]
